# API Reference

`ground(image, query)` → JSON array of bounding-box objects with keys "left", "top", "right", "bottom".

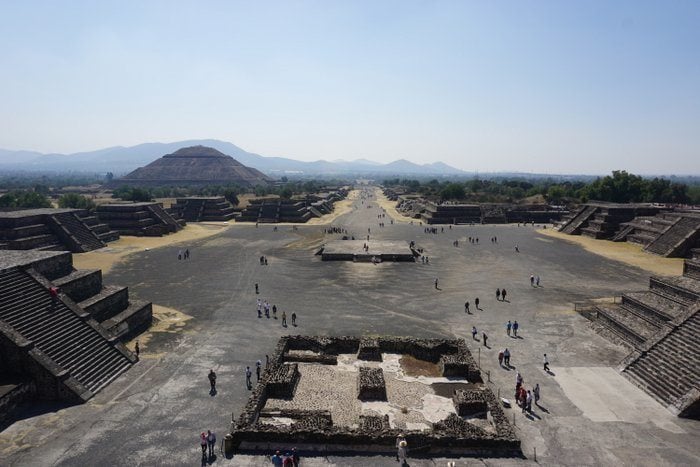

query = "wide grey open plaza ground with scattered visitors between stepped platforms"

[{"left": 0, "top": 187, "right": 700, "bottom": 466}]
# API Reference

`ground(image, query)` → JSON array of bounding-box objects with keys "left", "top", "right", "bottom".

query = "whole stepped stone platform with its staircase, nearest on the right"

[{"left": 586, "top": 260, "right": 700, "bottom": 418}]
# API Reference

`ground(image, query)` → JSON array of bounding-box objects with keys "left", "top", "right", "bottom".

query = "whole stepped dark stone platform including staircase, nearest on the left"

[{"left": 0, "top": 250, "right": 152, "bottom": 426}]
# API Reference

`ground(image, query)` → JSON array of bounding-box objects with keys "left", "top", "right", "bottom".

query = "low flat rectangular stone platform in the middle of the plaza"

[{"left": 319, "top": 240, "right": 415, "bottom": 262}]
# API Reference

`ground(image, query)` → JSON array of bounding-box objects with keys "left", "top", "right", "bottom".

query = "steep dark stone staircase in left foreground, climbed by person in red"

[{"left": 0, "top": 268, "right": 132, "bottom": 398}]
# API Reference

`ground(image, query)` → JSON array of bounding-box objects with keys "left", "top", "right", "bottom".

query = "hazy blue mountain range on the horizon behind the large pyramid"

[{"left": 0, "top": 139, "right": 466, "bottom": 177}]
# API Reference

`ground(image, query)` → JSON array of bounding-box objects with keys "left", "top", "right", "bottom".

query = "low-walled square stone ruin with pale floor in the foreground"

[{"left": 231, "top": 336, "right": 522, "bottom": 456}]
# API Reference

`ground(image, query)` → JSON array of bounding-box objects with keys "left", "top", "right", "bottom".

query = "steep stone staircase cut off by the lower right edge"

[{"left": 623, "top": 308, "right": 700, "bottom": 418}]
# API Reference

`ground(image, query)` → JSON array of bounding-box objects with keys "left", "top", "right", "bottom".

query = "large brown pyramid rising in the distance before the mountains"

[{"left": 114, "top": 146, "right": 272, "bottom": 186}]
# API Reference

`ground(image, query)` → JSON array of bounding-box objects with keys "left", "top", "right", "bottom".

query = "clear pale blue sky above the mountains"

[{"left": 0, "top": 0, "right": 700, "bottom": 174}]
